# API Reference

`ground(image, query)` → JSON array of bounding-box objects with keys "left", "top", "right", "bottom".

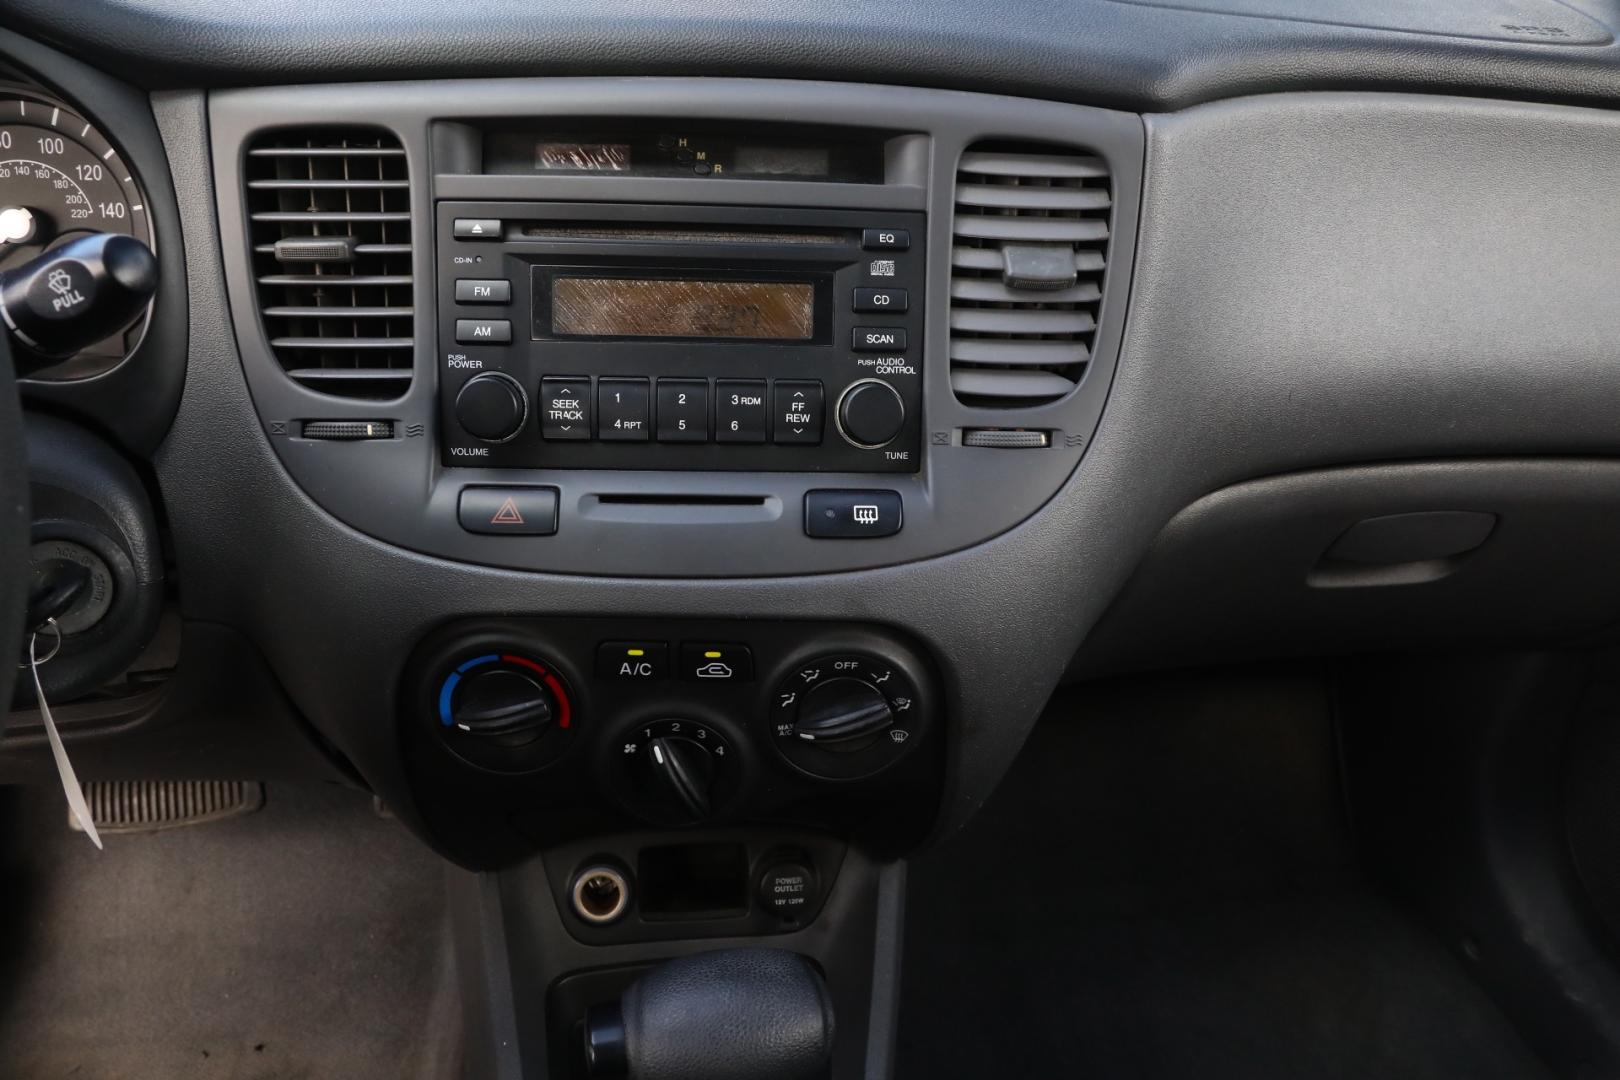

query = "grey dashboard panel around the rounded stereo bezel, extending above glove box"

[{"left": 156, "top": 87, "right": 1620, "bottom": 854}]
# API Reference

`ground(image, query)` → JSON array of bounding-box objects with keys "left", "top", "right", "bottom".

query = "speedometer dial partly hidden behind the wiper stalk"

[{"left": 0, "top": 84, "right": 156, "bottom": 377}]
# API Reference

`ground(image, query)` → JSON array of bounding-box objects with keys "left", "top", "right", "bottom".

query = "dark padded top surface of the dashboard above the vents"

[{"left": 9, "top": 0, "right": 1620, "bottom": 110}]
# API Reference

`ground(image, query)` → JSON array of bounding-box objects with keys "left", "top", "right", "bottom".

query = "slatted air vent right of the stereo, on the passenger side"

[{"left": 951, "top": 142, "right": 1113, "bottom": 408}]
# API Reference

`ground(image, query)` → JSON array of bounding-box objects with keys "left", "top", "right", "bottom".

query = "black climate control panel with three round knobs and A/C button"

[{"left": 402, "top": 619, "right": 943, "bottom": 861}]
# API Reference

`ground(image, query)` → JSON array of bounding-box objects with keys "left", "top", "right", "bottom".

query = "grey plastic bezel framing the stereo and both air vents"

[{"left": 211, "top": 79, "right": 1142, "bottom": 576}]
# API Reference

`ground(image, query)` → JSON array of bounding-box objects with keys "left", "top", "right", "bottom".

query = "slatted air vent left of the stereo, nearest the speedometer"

[{"left": 245, "top": 128, "right": 413, "bottom": 398}]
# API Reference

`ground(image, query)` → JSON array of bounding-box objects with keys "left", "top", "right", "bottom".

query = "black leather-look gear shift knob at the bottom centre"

[{"left": 585, "top": 949, "right": 833, "bottom": 1080}]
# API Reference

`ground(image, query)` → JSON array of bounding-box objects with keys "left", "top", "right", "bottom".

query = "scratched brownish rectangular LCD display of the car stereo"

[{"left": 551, "top": 275, "right": 815, "bottom": 342}]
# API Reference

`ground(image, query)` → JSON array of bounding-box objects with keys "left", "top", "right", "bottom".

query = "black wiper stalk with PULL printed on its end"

[{"left": 0, "top": 233, "right": 157, "bottom": 366}]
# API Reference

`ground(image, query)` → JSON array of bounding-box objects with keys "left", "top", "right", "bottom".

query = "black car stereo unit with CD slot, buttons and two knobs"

[{"left": 437, "top": 202, "right": 925, "bottom": 473}]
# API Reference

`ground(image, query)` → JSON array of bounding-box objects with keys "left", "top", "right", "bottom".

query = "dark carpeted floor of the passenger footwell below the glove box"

[{"left": 897, "top": 672, "right": 1547, "bottom": 1080}]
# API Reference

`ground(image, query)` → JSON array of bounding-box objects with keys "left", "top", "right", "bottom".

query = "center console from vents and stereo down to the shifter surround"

[{"left": 207, "top": 79, "right": 1142, "bottom": 1080}]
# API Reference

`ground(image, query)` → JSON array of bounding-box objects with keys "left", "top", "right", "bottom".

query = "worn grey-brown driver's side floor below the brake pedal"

[{"left": 0, "top": 785, "right": 457, "bottom": 1080}]
